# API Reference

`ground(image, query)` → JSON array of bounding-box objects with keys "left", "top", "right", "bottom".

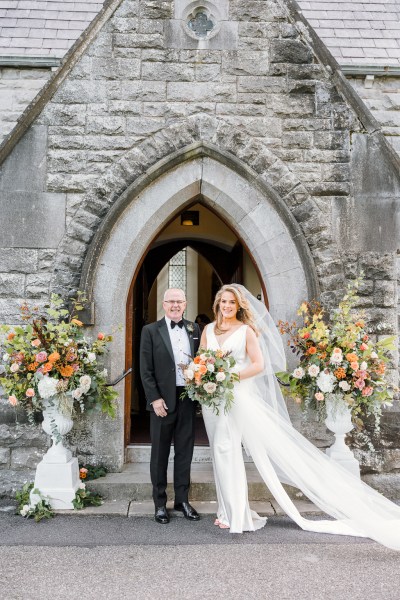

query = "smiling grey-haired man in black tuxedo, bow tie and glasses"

[{"left": 140, "top": 289, "right": 200, "bottom": 523}]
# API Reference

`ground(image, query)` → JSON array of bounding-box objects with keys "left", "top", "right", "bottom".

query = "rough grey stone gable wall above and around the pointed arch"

[{"left": 0, "top": 0, "right": 400, "bottom": 482}]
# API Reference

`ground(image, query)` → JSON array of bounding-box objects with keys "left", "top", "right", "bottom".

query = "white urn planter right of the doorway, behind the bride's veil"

[{"left": 325, "top": 394, "right": 360, "bottom": 477}]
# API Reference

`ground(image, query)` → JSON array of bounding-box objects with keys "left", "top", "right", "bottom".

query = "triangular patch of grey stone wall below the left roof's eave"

[{"left": 0, "top": 67, "right": 51, "bottom": 143}]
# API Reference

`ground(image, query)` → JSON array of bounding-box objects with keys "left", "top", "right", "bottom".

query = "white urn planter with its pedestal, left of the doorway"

[{"left": 31, "top": 396, "right": 80, "bottom": 510}]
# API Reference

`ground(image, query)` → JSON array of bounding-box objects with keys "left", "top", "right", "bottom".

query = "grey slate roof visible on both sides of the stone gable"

[{"left": 0, "top": 0, "right": 400, "bottom": 66}]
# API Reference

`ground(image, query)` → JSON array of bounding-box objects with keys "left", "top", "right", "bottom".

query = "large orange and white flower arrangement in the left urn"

[{"left": 0, "top": 294, "right": 117, "bottom": 422}]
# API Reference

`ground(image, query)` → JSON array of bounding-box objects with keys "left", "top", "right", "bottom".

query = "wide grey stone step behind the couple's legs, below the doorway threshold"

[{"left": 87, "top": 463, "right": 303, "bottom": 502}]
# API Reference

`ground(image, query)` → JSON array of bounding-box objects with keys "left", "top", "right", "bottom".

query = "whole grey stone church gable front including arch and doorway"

[{"left": 0, "top": 0, "right": 400, "bottom": 492}]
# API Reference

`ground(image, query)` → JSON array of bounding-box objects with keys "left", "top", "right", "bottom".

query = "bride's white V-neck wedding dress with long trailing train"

[{"left": 203, "top": 323, "right": 400, "bottom": 550}]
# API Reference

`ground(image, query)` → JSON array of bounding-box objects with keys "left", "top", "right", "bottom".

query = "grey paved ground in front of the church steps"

[{"left": 0, "top": 512, "right": 400, "bottom": 600}]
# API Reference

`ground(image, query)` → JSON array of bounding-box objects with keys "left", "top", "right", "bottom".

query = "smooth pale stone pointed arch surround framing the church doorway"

[{"left": 73, "top": 144, "right": 318, "bottom": 469}]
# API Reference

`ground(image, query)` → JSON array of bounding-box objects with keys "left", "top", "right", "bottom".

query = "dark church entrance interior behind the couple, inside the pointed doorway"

[{"left": 125, "top": 204, "right": 261, "bottom": 445}]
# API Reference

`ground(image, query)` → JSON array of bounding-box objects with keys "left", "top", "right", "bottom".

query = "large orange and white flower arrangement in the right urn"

[{"left": 277, "top": 280, "right": 396, "bottom": 428}]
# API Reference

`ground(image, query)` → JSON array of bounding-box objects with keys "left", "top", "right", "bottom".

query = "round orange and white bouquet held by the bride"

[{"left": 182, "top": 348, "right": 239, "bottom": 414}]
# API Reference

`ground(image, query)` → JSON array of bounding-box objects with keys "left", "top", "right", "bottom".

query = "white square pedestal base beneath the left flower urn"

[{"left": 33, "top": 454, "right": 81, "bottom": 510}]
